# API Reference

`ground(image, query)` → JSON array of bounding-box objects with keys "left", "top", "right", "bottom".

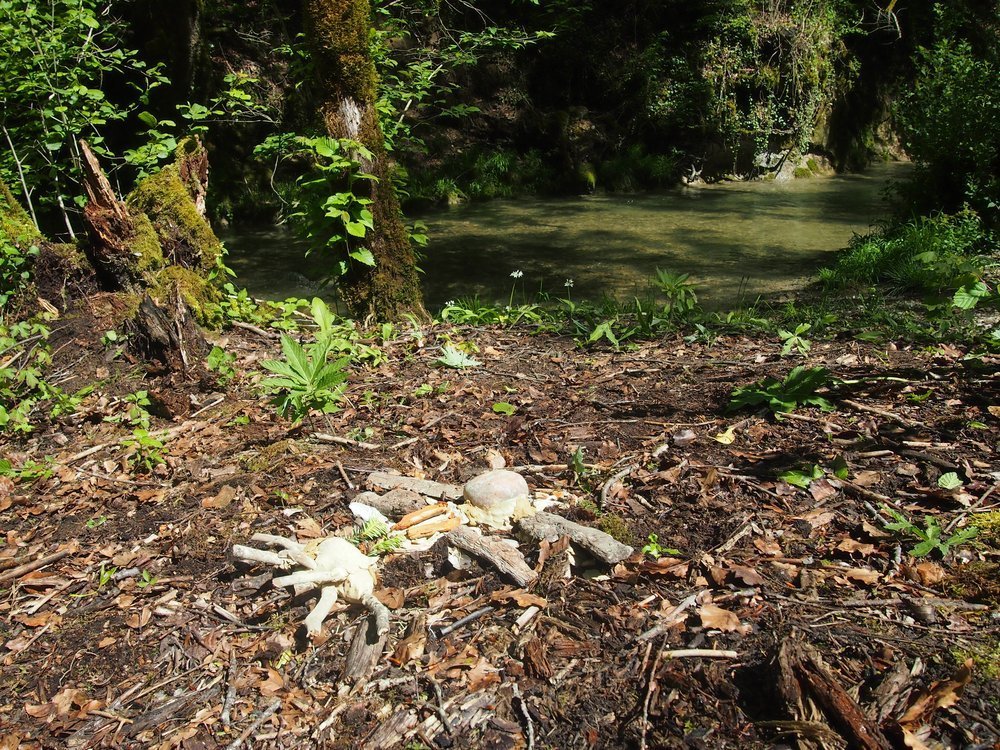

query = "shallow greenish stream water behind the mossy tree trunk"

[{"left": 223, "top": 164, "right": 907, "bottom": 310}]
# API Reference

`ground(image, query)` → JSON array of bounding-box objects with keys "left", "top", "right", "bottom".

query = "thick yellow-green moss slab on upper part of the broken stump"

[{"left": 127, "top": 164, "right": 222, "bottom": 273}]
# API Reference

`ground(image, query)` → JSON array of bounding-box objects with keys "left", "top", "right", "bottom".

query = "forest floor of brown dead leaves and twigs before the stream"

[{"left": 0, "top": 302, "right": 1000, "bottom": 750}]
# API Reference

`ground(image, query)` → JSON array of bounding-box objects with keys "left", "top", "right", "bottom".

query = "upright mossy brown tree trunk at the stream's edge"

[{"left": 304, "top": 0, "right": 426, "bottom": 320}]
